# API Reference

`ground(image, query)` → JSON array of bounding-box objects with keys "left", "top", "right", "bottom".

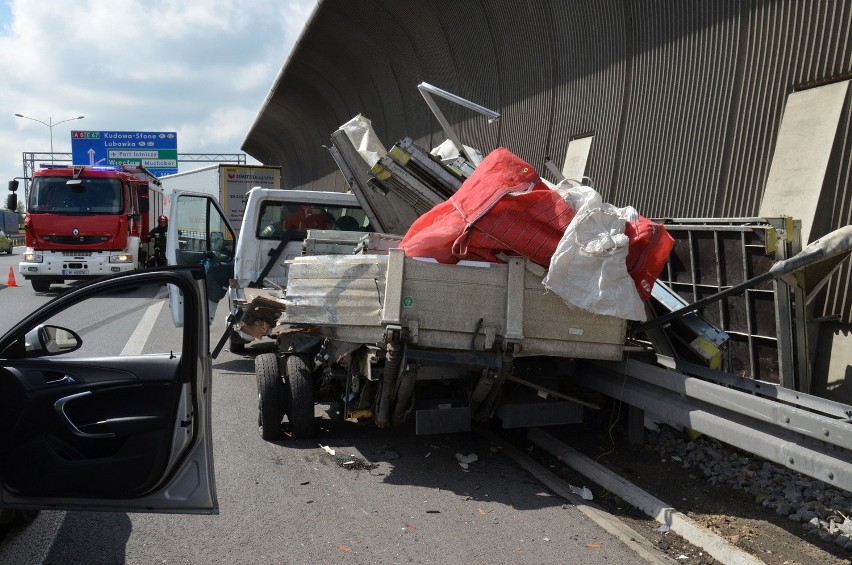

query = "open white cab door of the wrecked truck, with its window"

[{"left": 166, "top": 190, "right": 237, "bottom": 327}]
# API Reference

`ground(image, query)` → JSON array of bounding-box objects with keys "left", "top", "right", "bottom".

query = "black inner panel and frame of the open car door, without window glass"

[{"left": 0, "top": 269, "right": 217, "bottom": 513}]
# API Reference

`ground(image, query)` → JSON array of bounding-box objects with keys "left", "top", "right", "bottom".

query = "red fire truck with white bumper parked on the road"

[{"left": 18, "top": 165, "right": 163, "bottom": 292}]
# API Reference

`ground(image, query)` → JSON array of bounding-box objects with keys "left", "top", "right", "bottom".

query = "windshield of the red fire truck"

[{"left": 27, "top": 177, "right": 122, "bottom": 214}]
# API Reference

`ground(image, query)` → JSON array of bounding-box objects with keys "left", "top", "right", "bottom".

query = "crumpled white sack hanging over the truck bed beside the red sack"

[{"left": 542, "top": 182, "right": 645, "bottom": 321}]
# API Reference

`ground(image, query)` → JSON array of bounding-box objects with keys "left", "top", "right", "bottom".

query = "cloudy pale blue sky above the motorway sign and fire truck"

[{"left": 0, "top": 0, "right": 316, "bottom": 200}]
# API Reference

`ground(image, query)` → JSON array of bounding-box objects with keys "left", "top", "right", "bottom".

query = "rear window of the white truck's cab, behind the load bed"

[{"left": 256, "top": 202, "right": 373, "bottom": 240}]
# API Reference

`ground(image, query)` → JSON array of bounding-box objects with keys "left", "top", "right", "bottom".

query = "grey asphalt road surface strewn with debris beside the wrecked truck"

[{"left": 0, "top": 248, "right": 660, "bottom": 564}]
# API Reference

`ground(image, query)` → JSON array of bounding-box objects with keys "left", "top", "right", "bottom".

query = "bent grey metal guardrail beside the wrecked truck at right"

[{"left": 569, "top": 358, "right": 852, "bottom": 491}]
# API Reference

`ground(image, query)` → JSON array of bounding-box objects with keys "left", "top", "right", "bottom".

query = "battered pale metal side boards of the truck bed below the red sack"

[{"left": 281, "top": 249, "right": 627, "bottom": 360}]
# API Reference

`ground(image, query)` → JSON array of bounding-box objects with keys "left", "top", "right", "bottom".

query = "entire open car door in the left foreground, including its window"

[{"left": 0, "top": 266, "right": 218, "bottom": 514}]
